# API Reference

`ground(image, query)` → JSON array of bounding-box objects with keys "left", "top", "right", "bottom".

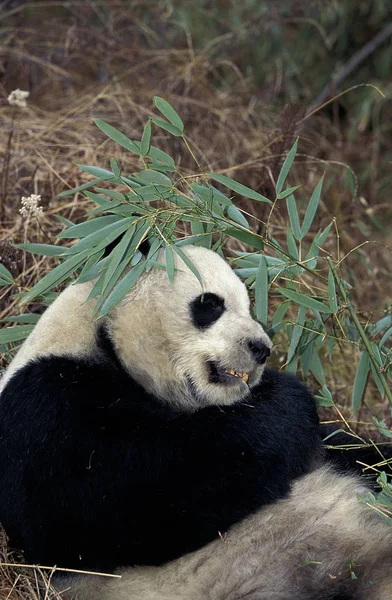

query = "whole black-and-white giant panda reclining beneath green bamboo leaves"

[{"left": 0, "top": 246, "right": 392, "bottom": 600}]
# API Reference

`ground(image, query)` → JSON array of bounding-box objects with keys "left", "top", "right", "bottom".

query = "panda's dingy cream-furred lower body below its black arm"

[{"left": 58, "top": 467, "right": 392, "bottom": 600}]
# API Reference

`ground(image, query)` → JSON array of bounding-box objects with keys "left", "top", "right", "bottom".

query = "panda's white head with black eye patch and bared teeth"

[{"left": 107, "top": 246, "right": 272, "bottom": 410}]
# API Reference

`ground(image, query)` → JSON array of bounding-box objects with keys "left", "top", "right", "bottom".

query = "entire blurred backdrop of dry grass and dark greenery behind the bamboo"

[{"left": 0, "top": 0, "right": 392, "bottom": 600}]
